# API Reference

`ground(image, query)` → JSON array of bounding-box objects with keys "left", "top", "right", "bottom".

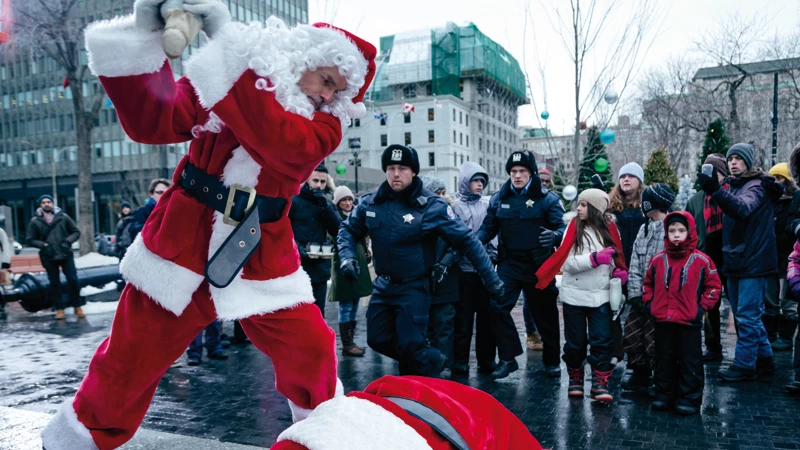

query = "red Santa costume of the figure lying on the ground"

[{"left": 271, "top": 376, "right": 542, "bottom": 450}]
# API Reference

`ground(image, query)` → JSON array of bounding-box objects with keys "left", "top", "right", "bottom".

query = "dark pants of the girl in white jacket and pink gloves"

[{"left": 562, "top": 303, "right": 614, "bottom": 372}]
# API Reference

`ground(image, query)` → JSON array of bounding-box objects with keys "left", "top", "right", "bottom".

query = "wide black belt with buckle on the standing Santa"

[{"left": 181, "top": 163, "right": 287, "bottom": 288}]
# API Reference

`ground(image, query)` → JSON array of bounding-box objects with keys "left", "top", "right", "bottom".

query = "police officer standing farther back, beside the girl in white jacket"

[{"left": 477, "top": 152, "right": 566, "bottom": 379}]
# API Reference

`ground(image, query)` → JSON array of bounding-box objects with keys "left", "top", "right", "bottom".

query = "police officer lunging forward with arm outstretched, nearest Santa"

[{"left": 337, "top": 145, "right": 503, "bottom": 376}]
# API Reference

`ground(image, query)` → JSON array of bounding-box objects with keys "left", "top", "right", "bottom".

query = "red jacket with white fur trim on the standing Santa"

[{"left": 86, "top": 17, "right": 375, "bottom": 319}]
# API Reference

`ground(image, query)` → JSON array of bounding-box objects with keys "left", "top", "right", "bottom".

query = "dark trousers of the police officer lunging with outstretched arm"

[{"left": 367, "top": 277, "right": 441, "bottom": 376}]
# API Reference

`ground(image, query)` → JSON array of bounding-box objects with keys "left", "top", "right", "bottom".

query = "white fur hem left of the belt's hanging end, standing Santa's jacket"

[{"left": 119, "top": 233, "right": 204, "bottom": 316}]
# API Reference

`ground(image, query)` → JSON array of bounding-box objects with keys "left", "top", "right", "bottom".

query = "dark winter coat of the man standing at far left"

[{"left": 25, "top": 207, "right": 81, "bottom": 261}]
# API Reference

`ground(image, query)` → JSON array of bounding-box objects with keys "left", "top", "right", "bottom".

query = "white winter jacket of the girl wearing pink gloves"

[{"left": 559, "top": 217, "right": 614, "bottom": 308}]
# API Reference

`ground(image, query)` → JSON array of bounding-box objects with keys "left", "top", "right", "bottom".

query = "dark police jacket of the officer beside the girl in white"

[{"left": 477, "top": 176, "right": 566, "bottom": 266}]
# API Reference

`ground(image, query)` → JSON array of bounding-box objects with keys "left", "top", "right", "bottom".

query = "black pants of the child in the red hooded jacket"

[{"left": 653, "top": 322, "right": 705, "bottom": 407}]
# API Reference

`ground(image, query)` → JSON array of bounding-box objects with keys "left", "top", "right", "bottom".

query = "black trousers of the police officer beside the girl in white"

[{"left": 489, "top": 260, "right": 561, "bottom": 366}]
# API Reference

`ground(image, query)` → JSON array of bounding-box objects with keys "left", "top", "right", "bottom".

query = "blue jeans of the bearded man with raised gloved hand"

[{"left": 728, "top": 277, "right": 772, "bottom": 370}]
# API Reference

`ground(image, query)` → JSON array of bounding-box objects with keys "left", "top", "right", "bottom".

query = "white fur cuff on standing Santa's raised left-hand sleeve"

[{"left": 85, "top": 15, "right": 167, "bottom": 77}]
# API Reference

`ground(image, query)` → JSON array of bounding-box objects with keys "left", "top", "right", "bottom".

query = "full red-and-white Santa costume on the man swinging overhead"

[{"left": 42, "top": 0, "right": 376, "bottom": 450}]
